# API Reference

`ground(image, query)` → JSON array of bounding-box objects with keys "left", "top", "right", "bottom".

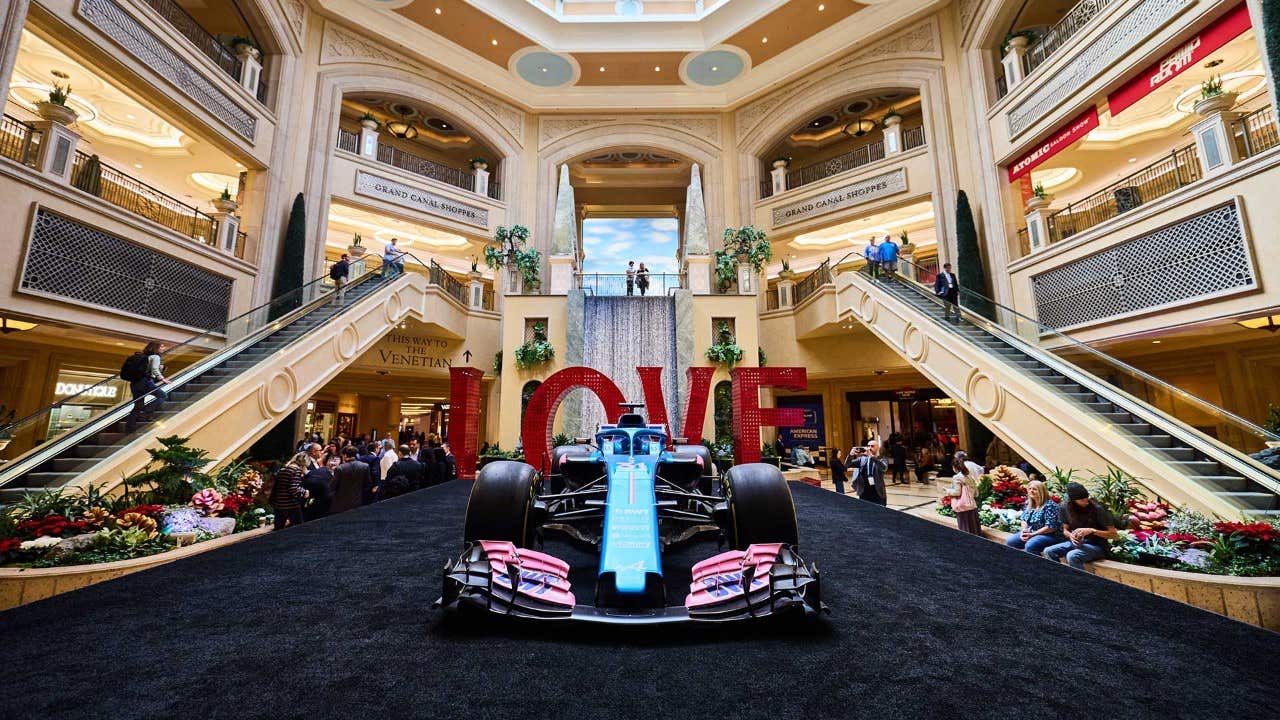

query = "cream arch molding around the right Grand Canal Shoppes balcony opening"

[{"left": 737, "top": 56, "right": 959, "bottom": 260}]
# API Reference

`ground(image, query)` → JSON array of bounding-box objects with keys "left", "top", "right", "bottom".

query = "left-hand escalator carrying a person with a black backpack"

[{"left": 0, "top": 257, "right": 414, "bottom": 502}]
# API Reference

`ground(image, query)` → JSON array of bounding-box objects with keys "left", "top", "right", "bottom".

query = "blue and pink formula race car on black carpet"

[{"left": 439, "top": 405, "right": 826, "bottom": 623}]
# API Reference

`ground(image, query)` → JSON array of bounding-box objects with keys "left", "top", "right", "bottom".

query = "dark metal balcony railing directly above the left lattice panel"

[{"left": 72, "top": 150, "right": 218, "bottom": 246}]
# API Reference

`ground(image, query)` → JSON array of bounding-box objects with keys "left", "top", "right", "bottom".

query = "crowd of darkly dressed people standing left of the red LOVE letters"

[{"left": 270, "top": 434, "right": 457, "bottom": 530}]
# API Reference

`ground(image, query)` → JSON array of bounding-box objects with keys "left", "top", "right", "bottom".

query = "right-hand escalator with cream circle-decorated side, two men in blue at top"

[{"left": 837, "top": 257, "right": 1280, "bottom": 519}]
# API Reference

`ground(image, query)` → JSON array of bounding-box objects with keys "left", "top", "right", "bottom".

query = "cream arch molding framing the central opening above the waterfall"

[{"left": 534, "top": 115, "right": 726, "bottom": 255}]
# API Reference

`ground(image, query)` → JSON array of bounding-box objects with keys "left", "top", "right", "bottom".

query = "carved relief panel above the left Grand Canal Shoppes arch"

[{"left": 317, "top": 21, "right": 525, "bottom": 146}]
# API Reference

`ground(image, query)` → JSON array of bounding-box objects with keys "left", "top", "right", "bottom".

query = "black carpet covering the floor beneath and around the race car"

[{"left": 0, "top": 483, "right": 1280, "bottom": 720}]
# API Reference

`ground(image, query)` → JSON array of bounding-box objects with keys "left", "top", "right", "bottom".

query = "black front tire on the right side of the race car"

[{"left": 722, "top": 462, "right": 800, "bottom": 550}]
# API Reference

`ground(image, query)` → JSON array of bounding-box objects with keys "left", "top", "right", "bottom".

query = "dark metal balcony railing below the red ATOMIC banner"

[{"left": 1048, "top": 145, "right": 1203, "bottom": 242}]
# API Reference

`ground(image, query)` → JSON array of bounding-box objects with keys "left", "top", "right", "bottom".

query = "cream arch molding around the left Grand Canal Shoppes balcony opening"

[{"left": 303, "top": 60, "right": 524, "bottom": 277}]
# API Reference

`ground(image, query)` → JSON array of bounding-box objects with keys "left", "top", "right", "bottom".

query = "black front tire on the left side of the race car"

[{"left": 462, "top": 460, "right": 539, "bottom": 547}]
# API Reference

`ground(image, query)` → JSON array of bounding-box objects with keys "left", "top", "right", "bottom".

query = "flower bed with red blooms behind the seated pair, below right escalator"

[{"left": 936, "top": 466, "right": 1280, "bottom": 578}]
